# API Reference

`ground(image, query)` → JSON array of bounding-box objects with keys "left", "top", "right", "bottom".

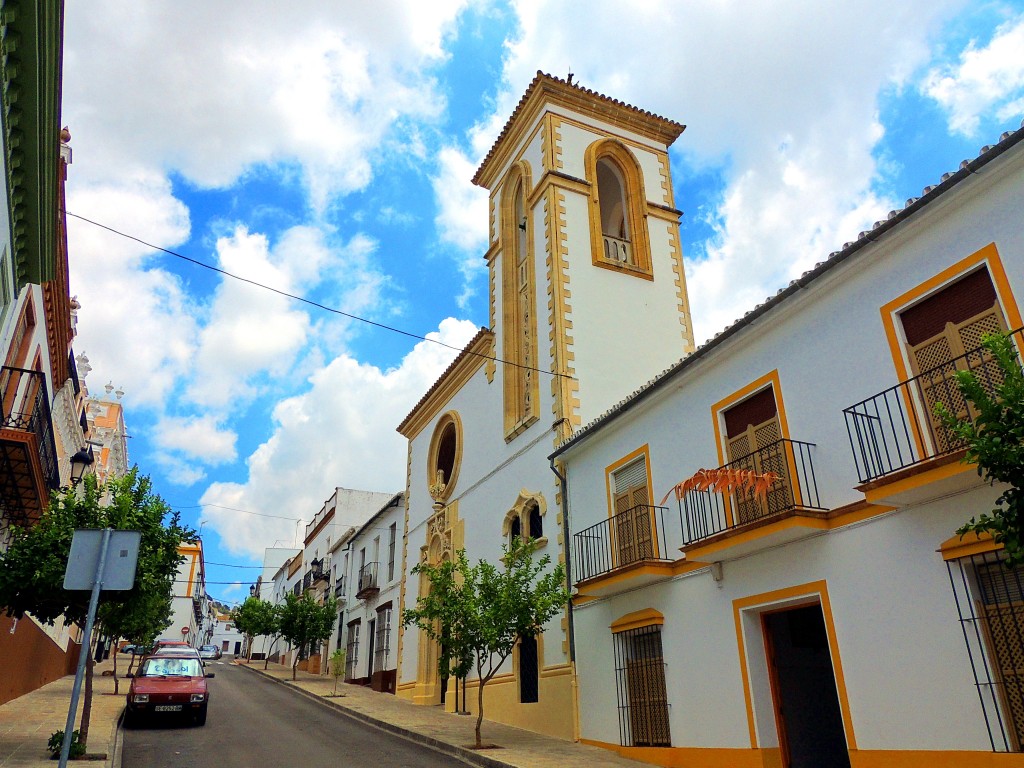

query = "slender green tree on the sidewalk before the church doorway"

[{"left": 402, "top": 539, "right": 569, "bottom": 748}]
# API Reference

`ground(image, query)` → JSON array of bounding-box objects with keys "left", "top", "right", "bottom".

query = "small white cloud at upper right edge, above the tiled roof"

[{"left": 922, "top": 16, "right": 1024, "bottom": 137}]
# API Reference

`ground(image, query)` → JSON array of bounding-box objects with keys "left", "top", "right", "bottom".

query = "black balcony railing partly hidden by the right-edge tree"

[{"left": 843, "top": 329, "right": 1024, "bottom": 482}]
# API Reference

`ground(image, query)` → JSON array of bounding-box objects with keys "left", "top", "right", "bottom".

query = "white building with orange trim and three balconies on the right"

[{"left": 552, "top": 105, "right": 1024, "bottom": 767}]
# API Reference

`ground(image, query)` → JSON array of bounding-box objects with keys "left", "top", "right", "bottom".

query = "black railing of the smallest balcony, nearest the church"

[{"left": 572, "top": 505, "right": 674, "bottom": 583}]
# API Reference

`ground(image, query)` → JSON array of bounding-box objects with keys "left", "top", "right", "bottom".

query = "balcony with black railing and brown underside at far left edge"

[{"left": 0, "top": 366, "right": 60, "bottom": 537}]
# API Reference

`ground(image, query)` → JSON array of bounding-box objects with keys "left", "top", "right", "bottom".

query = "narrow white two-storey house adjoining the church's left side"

[{"left": 335, "top": 494, "right": 406, "bottom": 693}]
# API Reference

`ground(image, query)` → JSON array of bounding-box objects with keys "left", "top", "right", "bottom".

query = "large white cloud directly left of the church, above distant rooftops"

[{"left": 201, "top": 318, "right": 478, "bottom": 557}]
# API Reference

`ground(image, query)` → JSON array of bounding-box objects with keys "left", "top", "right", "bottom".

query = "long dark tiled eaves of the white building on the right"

[{"left": 548, "top": 121, "right": 1024, "bottom": 460}]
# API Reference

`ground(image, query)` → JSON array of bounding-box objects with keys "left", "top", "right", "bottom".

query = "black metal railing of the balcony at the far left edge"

[{"left": 0, "top": 366, "right": 60, "bottom": 490}]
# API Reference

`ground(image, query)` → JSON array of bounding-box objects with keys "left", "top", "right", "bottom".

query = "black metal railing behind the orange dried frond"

[{"left": 679, "top": 438, "right": 824, "bottom": 545}]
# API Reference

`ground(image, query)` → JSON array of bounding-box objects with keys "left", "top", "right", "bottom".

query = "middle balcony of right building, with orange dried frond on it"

[{"left": 679, "top": 439, "right": 827, "bottom": 561}]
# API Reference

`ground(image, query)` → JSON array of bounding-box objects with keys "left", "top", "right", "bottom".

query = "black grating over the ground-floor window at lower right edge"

[{"left": 946, "top": 552, "right": 1024, "bottom": 752}]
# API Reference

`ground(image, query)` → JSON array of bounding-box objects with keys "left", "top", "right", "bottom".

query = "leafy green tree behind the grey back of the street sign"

[{"left": 0, "top": 467, "right": 196, "bottom": 743}]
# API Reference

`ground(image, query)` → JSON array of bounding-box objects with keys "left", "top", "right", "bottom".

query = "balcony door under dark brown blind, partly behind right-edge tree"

[{"left": 899, "top": 267, "right": 1007, "bottom": 454}]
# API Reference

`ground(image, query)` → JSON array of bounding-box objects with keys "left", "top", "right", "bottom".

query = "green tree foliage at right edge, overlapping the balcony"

[{"left": 935, "top": 334, "right": 1024, "bottom": 567}]
